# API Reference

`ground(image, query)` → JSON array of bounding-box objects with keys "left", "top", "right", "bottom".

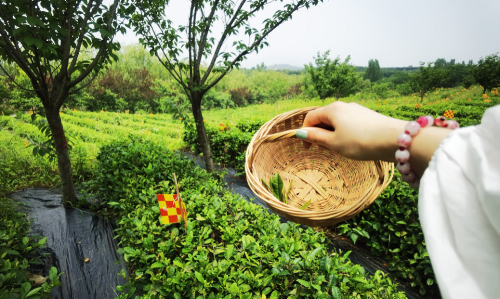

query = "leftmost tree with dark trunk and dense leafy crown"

[{"left": 0, "top": 0, "right": 122, "bottom": 203}]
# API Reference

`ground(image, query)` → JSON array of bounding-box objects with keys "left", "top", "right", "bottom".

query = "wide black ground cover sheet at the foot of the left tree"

[{"left": 9, "top": 188, "right": 126, "bottom": 299}]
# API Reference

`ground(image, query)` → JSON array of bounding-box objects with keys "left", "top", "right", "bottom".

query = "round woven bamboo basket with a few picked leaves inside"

[{"left": 245, "top": 107, "right": 394, "bottom": 227}]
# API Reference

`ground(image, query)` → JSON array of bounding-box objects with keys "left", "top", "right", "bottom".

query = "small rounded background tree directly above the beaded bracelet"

[{"left": 409, "top": 62, "right": 448, "bottom": 103}]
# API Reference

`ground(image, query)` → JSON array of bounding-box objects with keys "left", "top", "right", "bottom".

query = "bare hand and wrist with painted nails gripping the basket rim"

[{"left": 296, "top": 102, "right": 451, "bottom": 176}]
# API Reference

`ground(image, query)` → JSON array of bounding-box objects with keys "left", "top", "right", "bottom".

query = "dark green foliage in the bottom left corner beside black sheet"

[{"left": 0, "top": 196, "right": 62, "bottom": 299}]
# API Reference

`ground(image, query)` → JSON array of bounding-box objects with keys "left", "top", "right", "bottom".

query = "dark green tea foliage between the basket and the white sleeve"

[{"left": 337, "top": 173, "right": 436, "bottom": 294}]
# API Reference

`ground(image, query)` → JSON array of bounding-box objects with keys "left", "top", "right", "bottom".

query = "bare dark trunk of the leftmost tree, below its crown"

[{"left": 45, "top": 108, "right": 77, "bottom": 205}]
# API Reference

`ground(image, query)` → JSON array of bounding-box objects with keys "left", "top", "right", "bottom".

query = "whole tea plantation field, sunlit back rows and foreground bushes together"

[{"left": 0, "top": 86, "right": 500, "bottom": 299}]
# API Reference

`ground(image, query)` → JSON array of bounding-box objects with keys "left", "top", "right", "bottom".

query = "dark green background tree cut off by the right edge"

[{"left": 471, "top": 54, "right": 500, "bottom": 94}]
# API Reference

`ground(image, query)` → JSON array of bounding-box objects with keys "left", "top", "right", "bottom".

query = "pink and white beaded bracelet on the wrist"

[{"left": 396, "top": 115, "right": 459, "bottom": 189}]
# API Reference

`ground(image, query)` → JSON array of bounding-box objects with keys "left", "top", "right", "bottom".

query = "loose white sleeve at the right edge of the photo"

[{"left": 419, "top": 105, "right": 500, "bottom": 299}]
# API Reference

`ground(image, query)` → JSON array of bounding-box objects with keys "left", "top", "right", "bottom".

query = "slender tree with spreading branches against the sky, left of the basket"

[{"left": 132, "top": 0, "right": 321, "bottom": 172}]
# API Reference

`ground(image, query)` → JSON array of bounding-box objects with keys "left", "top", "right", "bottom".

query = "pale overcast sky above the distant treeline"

[{"left": 116, "top": 0, "right": 500, "bottom": 68}]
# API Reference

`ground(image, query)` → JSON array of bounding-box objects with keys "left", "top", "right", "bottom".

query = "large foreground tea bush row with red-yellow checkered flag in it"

[{"left": 90, "top": 139, "right": 406, "bottom": 299}]
